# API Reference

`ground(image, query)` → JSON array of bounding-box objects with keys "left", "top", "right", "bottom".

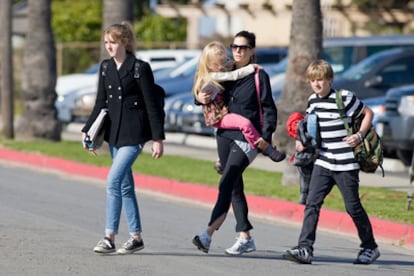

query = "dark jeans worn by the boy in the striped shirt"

[{"left": 299, "top": 165, "right": 377, "bottom": 251}]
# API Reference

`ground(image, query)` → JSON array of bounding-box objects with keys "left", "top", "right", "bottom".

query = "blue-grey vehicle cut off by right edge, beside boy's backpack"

[{"left": 376, "top": 84, "right": 414, "bottom": 166}]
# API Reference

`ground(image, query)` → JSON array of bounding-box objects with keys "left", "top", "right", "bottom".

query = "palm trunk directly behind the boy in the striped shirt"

[{"left": 276, "top": 0, "right": 323, "bottom": 184}]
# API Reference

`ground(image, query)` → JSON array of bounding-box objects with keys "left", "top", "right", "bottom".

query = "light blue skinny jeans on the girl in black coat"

[{"left": 105, "top": 145, "right": 143, "bottom": 235}]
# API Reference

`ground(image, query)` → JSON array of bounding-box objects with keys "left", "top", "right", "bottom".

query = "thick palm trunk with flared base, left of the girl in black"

[{"left": 16, "top": 0, "right": 61, "bottom": 141}]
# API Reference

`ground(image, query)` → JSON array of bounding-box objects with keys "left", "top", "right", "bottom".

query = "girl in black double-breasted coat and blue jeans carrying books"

[{"left": 82, "top": 22, "right": 165, "bottom": 254}]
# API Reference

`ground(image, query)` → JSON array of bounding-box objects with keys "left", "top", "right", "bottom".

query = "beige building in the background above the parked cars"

[{"left": 155, "top": 0, "right": 414, "bottom": 48}]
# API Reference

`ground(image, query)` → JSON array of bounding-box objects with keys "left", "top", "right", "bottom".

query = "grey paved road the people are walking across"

[{"left": 0, "top": 162, "right": 414, "bottom": 275}]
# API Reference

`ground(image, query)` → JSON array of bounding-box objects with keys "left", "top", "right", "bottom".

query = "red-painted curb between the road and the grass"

[{"left": 0, "top": 148, "right": 414, "bottom": 249}]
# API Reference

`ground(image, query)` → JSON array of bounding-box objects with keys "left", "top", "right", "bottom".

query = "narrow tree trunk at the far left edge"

[{"left": 0, "top": 0, "right": 14, "bottom": 139}]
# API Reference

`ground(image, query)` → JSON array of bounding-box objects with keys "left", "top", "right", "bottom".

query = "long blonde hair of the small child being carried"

[{"left": 193, "top": 41, "right": 227, "bottom": 95}]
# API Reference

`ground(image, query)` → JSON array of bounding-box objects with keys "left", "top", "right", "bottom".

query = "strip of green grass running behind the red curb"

[{"left": 0, "top": 140, "right": 414, "bottom": 224}]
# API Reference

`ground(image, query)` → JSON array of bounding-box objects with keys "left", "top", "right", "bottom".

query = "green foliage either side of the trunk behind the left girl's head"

[{"left": 52, "top": 0, "right": 187, "bottom": 43}]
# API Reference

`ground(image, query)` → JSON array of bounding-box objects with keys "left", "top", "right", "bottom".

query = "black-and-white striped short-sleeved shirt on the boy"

[{"left": 306, "top": 89, "right": 365, "bottom": 171}]
